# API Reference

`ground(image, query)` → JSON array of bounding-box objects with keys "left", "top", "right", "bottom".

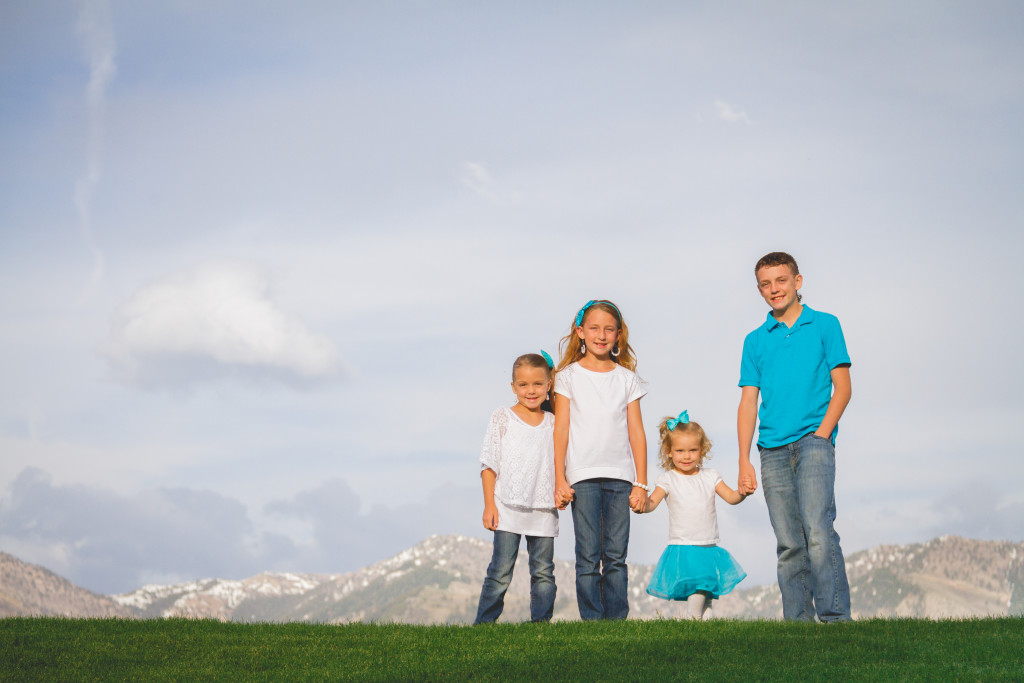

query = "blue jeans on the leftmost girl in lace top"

[{"left": 473, "top": 530, "right": 555, "bottom": 626}]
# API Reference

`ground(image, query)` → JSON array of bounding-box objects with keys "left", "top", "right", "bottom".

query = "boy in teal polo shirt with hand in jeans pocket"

[{"left": 736, "top": 252, "right": 851, "bottom": 622}]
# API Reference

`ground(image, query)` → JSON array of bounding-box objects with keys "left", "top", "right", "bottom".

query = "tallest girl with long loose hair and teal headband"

[{"left": 555, "top": 301, "right": 647, "bottom": 620}]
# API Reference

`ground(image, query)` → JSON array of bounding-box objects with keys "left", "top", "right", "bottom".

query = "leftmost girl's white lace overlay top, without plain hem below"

[{"left": 480, "top": 408, "right": 555, "bottom": 510}]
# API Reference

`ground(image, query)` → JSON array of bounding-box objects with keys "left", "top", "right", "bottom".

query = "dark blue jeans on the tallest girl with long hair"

[{"left": 572, "top": 479, "right": 633, "bottom": 620}]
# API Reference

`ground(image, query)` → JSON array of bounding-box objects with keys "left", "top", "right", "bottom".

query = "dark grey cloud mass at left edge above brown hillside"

[{"left": 0, "top": 468, "right": 280, "bottom": 593}]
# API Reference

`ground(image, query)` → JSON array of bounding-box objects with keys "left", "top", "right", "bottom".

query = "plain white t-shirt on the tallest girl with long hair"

[{"left": 555, "top": 362, "right": 647, "bottom": 485}]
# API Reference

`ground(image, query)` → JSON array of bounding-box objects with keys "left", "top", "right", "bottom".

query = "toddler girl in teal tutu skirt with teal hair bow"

[{"left": 643, "top": 411, "right": 746, "bottom": 620}]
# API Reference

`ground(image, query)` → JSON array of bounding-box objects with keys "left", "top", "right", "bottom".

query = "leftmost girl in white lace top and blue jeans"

[{"left": 474, "top": 351, "right": 558, "bottom": 624}]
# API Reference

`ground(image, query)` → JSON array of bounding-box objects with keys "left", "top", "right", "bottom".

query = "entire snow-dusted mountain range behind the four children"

[{"left": 0, "top": 536, "right": 1024, "bottom": 624}]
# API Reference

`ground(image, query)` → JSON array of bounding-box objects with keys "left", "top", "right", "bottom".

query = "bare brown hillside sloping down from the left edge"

[{"left": 0, "top": 553, "right": 134, "bottom": 617}]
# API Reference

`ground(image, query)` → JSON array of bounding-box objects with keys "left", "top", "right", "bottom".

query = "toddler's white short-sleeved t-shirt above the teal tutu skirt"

[{"left": 654, "top": 467, "right": 722, "bottom": 546}]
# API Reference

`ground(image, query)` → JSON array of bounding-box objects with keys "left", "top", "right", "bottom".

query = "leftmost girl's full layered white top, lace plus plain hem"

[{"left": 480, "top": 408, "right": 558, "bottom": 537}]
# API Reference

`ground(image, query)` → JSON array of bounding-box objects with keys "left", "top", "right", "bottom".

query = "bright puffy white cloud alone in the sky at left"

[{"left": 103, "top": 263, "right": 339, "bottom": 386}]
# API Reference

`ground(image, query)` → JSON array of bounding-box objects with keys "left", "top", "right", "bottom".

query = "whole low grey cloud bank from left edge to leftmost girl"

[{"left": 0, "top": 467, "right": 480, "bottom": 593}]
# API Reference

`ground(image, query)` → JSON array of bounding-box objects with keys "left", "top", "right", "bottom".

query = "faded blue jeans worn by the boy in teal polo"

[{"left": 760, "top": 434, "right": 850, "bottom": 622}]
